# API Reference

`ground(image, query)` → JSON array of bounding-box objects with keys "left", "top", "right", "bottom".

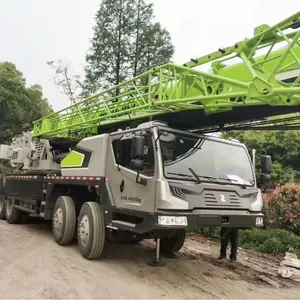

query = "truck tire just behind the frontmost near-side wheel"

[{"left": 52, "top": 196, "right": 76, "bottom": 245}]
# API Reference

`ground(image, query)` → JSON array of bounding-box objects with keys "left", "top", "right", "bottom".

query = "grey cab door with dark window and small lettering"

[{"left": 107, "top": 133, "right": 157, "bottom": 213}]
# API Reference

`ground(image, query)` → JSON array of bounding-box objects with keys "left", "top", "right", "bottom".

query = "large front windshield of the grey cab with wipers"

[{"left": 160, "top": 132, "right": 255, "bottom": 186}]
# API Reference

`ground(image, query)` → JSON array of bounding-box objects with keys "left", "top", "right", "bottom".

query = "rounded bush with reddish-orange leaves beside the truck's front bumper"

[{"left": 264, "top": 184, "right": 300, "bottom": 235}]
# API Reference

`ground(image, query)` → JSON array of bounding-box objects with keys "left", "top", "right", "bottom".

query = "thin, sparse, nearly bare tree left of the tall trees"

[{"left": 47, "top": 59, "right": 82, "bottom": 104}]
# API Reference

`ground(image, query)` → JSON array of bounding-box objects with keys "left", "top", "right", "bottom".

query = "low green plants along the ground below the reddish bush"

[{"left": 240, "top": 229, "right": 300, "bottom": 256}]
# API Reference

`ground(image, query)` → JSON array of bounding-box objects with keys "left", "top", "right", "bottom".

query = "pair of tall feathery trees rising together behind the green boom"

[{"left": 84, "top": 0, "right": 174, "bottom": 95}]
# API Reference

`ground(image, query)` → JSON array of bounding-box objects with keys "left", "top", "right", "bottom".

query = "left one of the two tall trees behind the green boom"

[{"left": 85, "top": 0, "right": 133, "bottom": 94}]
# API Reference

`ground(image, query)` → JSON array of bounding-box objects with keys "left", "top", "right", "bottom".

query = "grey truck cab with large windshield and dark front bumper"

[{"left": 62, "top": 122, "right": 270, "bottom": 240}]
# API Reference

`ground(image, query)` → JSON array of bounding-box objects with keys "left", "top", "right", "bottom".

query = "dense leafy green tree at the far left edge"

[{"left": 0, "top": 62, "right": 53, "bottom": 144}]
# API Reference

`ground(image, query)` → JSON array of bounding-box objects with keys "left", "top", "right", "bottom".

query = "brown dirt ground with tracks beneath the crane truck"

[{"left": 0, "top": 221, "right": 300, "bottom": 299}]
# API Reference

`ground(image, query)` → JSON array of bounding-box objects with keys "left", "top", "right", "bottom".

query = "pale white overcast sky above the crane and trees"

[{"left": 0, "top": 0, "right": 300, "bottom": 110}]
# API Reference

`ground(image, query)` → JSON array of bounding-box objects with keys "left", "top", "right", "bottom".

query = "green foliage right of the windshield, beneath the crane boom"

[{"left": 223, "top": 123, "right": 300, "bottom": 184}]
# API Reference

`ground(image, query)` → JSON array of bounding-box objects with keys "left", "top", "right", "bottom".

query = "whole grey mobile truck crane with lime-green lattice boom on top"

[{"left": 0, "top": 12, "right": 300, "bottom": 262}]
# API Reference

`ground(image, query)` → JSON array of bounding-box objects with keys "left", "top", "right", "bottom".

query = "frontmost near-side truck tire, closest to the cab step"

[{"left": 77, "top": 202, "right": 105, "bottom": 259}]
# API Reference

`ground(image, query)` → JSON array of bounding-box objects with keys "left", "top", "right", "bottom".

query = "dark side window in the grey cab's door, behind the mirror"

[{"left": 112, "top": 135, "right": 155, "bottom": 176}]
